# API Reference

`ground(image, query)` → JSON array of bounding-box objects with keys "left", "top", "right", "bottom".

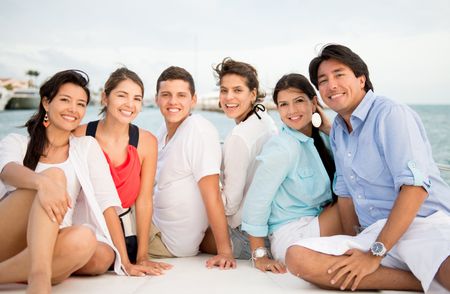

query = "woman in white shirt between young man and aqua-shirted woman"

[{"left": 202, "top": 58, "right": 277, "bottom": 259}]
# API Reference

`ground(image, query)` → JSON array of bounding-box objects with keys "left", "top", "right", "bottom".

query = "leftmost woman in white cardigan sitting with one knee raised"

[{"left": 0, "top": 70, "right": 124, "bottom": 293}]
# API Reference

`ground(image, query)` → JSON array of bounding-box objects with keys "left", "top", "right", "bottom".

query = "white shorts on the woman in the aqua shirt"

[{"left": 269, "top": 216, "right": 320, "bottom": 263}]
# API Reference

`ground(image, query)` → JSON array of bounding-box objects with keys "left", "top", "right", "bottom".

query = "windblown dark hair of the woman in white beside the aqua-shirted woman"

[{"left": 213, "top": 57, "right": 266, "bottom": 102}]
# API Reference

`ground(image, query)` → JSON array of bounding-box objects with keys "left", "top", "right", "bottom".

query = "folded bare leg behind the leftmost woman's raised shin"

[{"left": 0, "top": 226, "right": 97, "bottom": 284}]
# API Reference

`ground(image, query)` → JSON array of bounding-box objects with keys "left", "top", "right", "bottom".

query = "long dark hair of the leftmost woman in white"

[{"left": 23, "top": 69, "right": 90, "bottom": 170}]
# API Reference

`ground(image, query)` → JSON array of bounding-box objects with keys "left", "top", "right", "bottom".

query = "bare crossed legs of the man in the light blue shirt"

[{"left": 286, "top": 246, "right": 423, "bottom": 291}]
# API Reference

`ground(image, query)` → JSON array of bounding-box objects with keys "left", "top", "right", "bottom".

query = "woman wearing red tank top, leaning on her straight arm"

[{"left": 75, "top": 68, "right": 171, "bottom": 276}]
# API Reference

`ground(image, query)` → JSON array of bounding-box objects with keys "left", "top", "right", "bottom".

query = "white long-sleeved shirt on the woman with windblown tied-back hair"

[{"left": 221, "top": 112, "right": 278, "bottom": 228}]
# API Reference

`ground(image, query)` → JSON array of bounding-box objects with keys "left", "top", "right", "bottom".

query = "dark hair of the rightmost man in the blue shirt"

[{"left": 309, "top": 44, "right": 373, "bottom": 92}]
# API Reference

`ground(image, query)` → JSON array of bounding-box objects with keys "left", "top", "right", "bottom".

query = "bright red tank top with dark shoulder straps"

[{"left": 103, "top": 145, "right": 141, "bottom": 208}]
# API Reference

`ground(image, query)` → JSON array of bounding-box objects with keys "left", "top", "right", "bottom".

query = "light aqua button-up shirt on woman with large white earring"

[{"left": 242, "top": 125, "right": 331, "bottom": 237}]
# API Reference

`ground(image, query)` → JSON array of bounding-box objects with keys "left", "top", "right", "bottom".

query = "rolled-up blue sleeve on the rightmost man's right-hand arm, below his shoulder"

[{"left": 378, "top": 105, "right": 431, "bottom": 192}]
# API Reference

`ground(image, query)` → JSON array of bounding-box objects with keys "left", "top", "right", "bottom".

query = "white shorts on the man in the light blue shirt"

[{"left": 295, "top": 211, "right": 450, "bottom": 292}]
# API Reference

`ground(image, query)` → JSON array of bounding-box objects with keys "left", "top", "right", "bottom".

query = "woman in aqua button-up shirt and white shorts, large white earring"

[{"left": 242, "top": 74, "right": 342, "bottom": 273}]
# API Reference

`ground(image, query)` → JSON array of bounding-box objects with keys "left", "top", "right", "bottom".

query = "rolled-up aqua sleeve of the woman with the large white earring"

[{"left": 241, "top": 136, "right": 294, "bottom": 237}]
